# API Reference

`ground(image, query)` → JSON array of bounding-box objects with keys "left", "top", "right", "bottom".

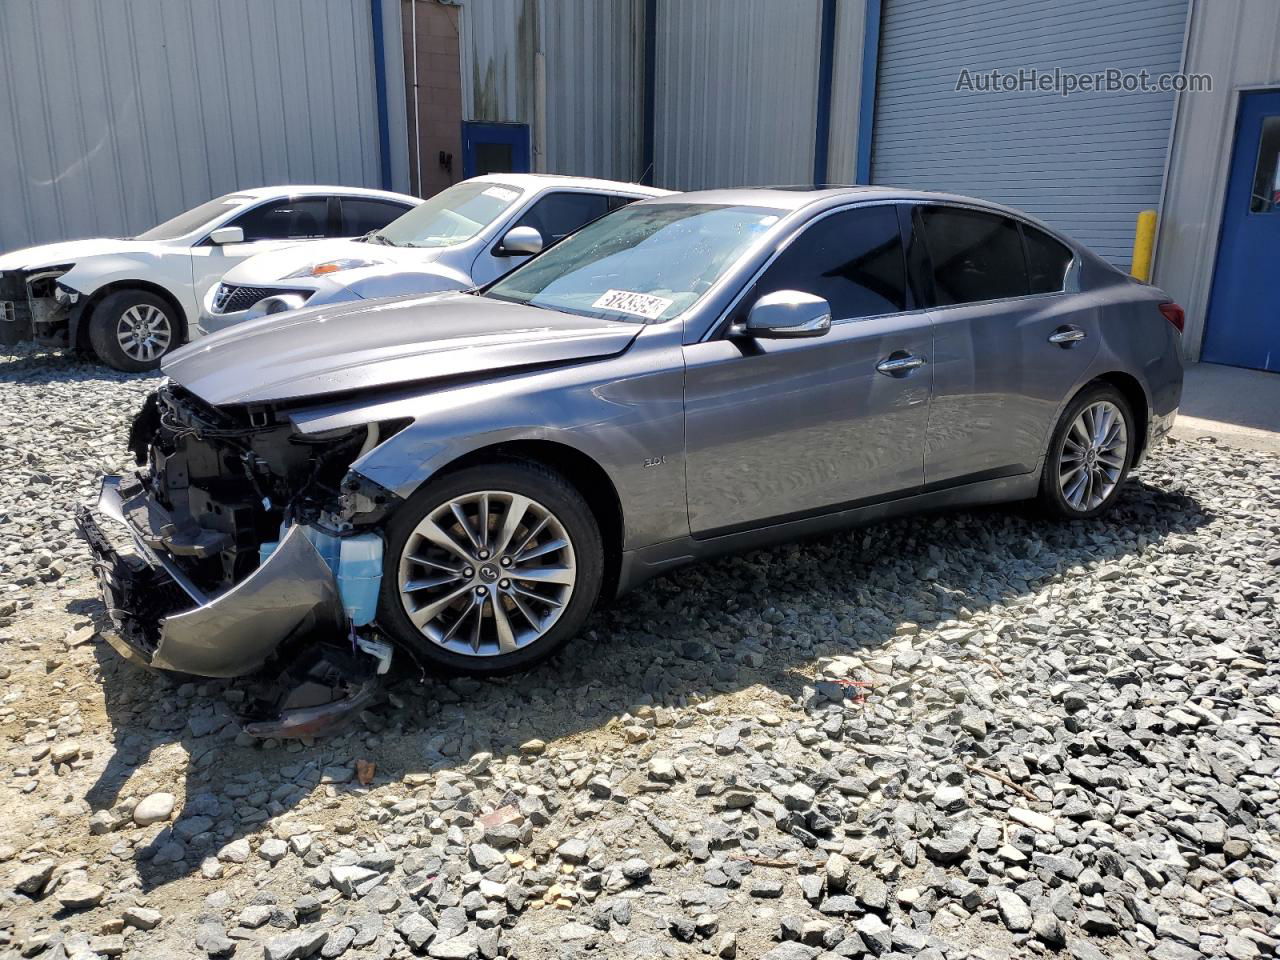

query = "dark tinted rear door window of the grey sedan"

[{"left": 920, "top": 206, "right": 1028, "bottom": 306}]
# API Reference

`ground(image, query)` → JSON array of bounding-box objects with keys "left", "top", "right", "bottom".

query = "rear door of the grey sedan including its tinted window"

[{"left": 908, "top": 205, "right": 1100, "bottom": 489}]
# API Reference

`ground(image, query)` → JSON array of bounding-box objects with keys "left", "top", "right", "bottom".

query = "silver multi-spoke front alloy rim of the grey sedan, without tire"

[{"left": 399, "top": 490, "right": 577, "bottom": 657}]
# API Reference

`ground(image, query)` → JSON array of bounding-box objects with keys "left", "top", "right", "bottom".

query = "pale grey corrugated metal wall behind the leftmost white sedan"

[{"left": 0, "top": 0, "right": 403, "bottom": 250}]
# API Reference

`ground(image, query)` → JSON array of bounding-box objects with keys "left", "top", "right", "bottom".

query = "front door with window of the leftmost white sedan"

[{"left": 191, "top": 196, "right": 347, "bottom": 303}]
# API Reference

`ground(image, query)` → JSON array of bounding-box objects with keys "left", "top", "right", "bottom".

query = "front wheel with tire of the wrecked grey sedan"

[{"left": 378, "top": 461, "right": 604, "bottom": 676}]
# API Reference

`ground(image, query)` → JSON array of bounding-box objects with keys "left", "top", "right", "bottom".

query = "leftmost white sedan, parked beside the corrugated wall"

[{"left": 0, "top": 187, "right": 422, "bottom": 370}]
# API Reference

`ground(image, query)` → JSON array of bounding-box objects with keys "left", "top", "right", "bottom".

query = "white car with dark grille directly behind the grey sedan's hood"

[{"left": 197, "top": 173, "right": 671, "bottom": 333}]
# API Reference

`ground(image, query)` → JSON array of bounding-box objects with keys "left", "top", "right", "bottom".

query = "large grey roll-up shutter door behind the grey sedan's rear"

[{"left": 872, "top": 0, "right": 1188, "bottom": 265}]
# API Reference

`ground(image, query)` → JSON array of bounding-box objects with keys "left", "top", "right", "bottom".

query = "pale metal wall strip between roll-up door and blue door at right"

[{"left": 1155, "top": 0, "right": 1280, "bottom": 360}]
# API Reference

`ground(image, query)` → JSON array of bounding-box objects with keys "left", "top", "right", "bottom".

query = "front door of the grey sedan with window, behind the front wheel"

[{"left": 685, "top": 204, "right": 933, "bottom": 536}]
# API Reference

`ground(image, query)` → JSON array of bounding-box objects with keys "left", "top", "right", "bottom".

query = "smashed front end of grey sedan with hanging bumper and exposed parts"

[{"left": 77, "top": 384, "right": 398, "bottom": 736}]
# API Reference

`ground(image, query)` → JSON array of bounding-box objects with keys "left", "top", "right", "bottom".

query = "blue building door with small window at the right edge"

[{"left": 1201, "top": 91, "right": 1280, "bottom": 370}]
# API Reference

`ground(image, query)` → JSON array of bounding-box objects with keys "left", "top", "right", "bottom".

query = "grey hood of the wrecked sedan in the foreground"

[{"left": 163, "top": 293, "right": 643, "bottom": 406}]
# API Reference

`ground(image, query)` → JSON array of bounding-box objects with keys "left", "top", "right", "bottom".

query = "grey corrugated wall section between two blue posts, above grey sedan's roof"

[{"left": 654, "top": 0, "right": 822, "bottom": 189}]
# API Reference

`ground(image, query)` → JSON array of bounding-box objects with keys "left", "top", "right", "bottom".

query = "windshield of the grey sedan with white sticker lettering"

[{"left": 485, "top": 204, "right": 781, "bottom": 323}]
